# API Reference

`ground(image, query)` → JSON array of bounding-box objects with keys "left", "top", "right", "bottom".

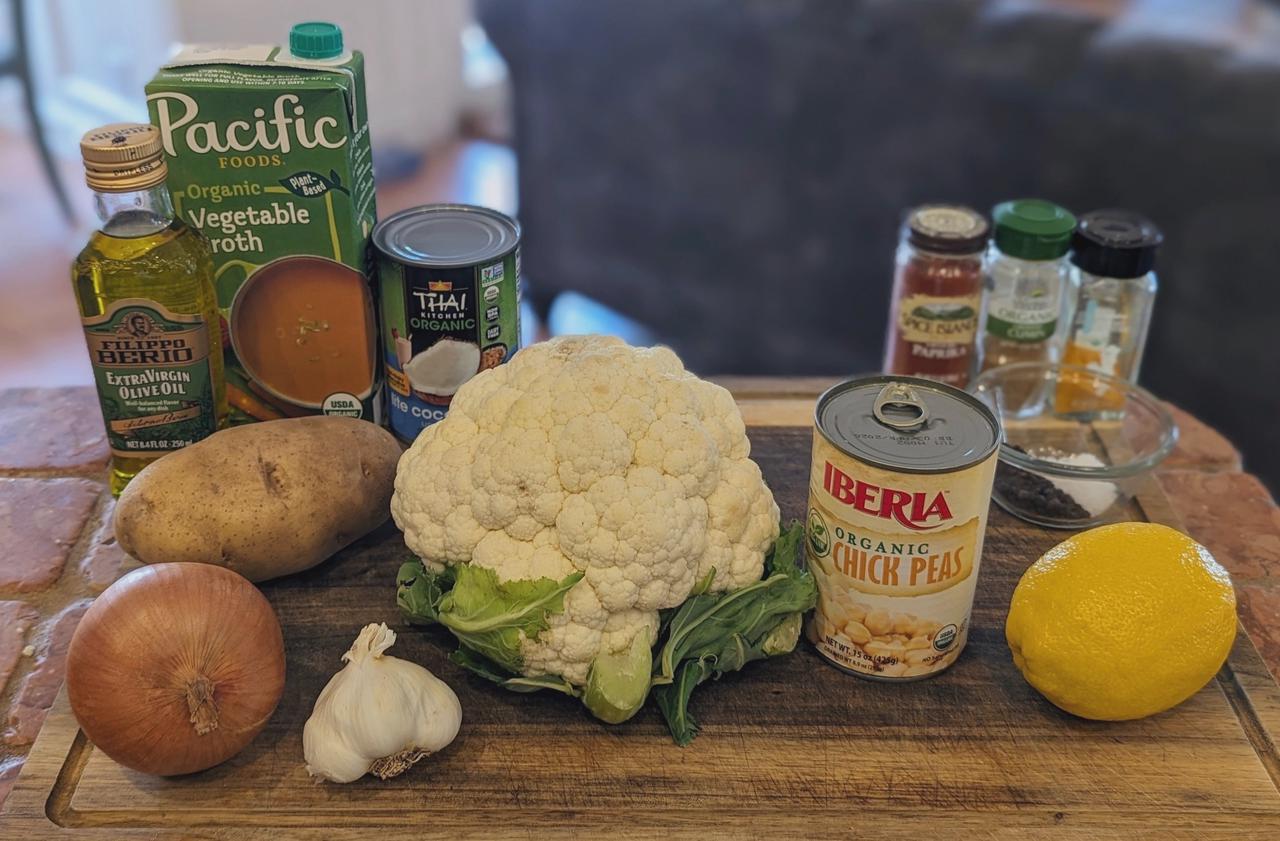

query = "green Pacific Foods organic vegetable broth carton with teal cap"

[{"left": 146, "top": 23, "right": 381, "bottom": 422}]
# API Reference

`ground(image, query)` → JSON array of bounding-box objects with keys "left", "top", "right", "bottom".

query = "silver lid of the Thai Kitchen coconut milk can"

[{"left": 374, "top": 205, "right": 520, "bottom": 269}]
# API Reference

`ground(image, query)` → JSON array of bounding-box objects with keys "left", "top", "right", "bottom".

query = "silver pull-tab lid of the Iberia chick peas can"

[{"left": 814, "top": 376, "right": 1001, "bottom": 474}]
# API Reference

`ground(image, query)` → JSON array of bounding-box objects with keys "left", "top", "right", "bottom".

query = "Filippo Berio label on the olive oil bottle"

[{"left": 83, "top": 298, "right": 218, "bottom": 458}]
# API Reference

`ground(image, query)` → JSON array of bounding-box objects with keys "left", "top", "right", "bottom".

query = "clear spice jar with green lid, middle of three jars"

[{"left": 982, "top": 198, "right": 1075, "bottom": 371}]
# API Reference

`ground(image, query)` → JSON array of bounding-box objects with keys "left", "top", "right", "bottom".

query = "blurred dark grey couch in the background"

[{"left": 477, "top": 0, "right": 1280, "bottom": 488}]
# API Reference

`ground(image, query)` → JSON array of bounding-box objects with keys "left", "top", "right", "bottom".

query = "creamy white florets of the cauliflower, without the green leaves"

[{"left": 392, "top": 335, "right": 778, "bottom": 687}]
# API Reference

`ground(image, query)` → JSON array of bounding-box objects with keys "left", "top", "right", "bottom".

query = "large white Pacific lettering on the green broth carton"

[{"left": 147, "top": 91, "right": 347, "bottom": 157}]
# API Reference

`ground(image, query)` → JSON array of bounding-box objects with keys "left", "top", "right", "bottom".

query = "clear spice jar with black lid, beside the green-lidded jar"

[{"left": 1057, "top": 210, "right": 1164, "bottom": 411}]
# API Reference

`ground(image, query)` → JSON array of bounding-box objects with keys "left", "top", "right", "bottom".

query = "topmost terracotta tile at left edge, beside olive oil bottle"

[{"left": 0, "top": 387, "right": 110, "bottom": 471}]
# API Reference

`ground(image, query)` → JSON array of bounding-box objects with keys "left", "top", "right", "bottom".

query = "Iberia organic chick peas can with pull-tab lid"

[{"left": 805, "top": 376, "right": 1001, "bottom": 680}]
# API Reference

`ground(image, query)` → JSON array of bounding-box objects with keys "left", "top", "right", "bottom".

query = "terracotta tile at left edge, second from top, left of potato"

[{"left": 0, "top": 479, "right": 102, "bottom": 593}]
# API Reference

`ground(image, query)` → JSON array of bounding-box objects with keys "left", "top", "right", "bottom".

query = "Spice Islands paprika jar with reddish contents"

[{"left": 884, "top": 205, "right": 989, "bottom": 388}]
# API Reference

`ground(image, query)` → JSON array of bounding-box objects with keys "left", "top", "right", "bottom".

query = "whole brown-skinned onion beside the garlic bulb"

[{"left": 67, "top": 563, "right": 284, "bottom": 777}]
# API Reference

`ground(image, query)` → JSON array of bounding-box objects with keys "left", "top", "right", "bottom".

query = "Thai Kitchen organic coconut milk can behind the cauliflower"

[{"left": 374, "top": 205, "right": 520, "bottom": 443}]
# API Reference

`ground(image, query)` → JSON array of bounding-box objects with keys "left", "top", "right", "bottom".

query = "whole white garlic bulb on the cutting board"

[{"left": 302, "top": 623, "right": 462, "bottom": 782}]
